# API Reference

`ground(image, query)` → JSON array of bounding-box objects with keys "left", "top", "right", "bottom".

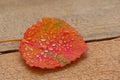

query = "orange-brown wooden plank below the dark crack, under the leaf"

[{"left": 0, "top": 38, "right": 120, "bottom": 80}]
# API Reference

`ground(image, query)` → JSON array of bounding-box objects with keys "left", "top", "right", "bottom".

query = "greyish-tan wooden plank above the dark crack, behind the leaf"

[{"left": 0, "top": 0, "right": 120, "bottom": 51}]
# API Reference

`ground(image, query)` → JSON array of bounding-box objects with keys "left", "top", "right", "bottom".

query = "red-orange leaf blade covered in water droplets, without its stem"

[{"left": 19, "top": 18, "right": 87, "bottom": 69}]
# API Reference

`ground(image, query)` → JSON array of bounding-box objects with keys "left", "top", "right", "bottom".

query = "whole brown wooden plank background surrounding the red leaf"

[{"left": 0, "top": 0, "right": 120, "bottom": 80}]
